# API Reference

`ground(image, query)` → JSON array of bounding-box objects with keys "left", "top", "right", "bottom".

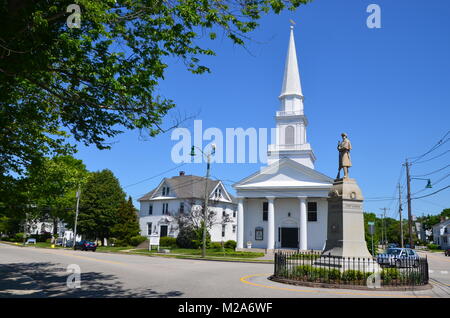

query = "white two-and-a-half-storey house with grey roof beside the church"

[{"left": 138, "top": 171, "right": 237, "bottom": 242}]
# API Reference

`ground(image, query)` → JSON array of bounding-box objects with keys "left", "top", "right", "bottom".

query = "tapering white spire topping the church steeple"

[{"left": 280, "top": 26, "right": 303, "bottom": 98}]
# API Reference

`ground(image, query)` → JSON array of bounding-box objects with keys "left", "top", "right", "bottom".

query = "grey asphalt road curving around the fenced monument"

[{"left": 0, "top": 244, "right": 450, "bottom": 298}]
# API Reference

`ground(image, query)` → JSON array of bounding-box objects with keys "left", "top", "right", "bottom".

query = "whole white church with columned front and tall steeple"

[{"left": 233, "top": 26, "right": 333, "bottom": 251}]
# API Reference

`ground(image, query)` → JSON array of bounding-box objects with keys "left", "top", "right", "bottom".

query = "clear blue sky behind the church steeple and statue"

[{"left": 72, "top": 0, "right": 450, "bottom": 218}]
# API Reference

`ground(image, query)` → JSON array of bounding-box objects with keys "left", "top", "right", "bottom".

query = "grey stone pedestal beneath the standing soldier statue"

[{"left": 323, "top": 178, "right": 372, "bottom": 258}]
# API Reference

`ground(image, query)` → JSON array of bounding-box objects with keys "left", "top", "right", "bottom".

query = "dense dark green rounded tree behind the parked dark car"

[{"left": 77, "top": 169, "right": 125, "bottom": 242}]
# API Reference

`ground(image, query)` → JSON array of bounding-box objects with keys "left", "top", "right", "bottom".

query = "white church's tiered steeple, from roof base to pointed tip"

[{"left": 268, "top": 26, "right": 316, "bottom": 169}]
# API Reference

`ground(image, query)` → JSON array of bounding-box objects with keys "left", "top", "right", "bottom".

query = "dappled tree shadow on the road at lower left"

[{"left": 0, "top": 262, "right": 183, "bottom": 298}]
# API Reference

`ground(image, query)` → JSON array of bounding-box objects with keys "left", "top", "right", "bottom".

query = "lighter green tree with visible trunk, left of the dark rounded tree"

[{"left": 27, "top": 156, "right": 88, "bottom": 237}]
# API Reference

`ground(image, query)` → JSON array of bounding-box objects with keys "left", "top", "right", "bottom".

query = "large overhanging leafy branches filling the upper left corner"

[{"left": 0, "top": 0, "right": 310, "bottom": 175}]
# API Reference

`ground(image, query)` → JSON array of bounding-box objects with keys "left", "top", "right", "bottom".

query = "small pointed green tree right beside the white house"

[{"left": 111, "top": 197, "right": 140, "bottom": 244}]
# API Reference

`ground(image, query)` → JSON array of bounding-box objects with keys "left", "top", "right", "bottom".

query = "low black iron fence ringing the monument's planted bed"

[{"left": 273, "top": 250, "right": 428, "bottom": 287}]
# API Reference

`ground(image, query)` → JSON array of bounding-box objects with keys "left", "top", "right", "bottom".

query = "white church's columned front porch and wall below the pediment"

[{"left": 237, "top": 195, "right": 328, "bottom": 250}]
